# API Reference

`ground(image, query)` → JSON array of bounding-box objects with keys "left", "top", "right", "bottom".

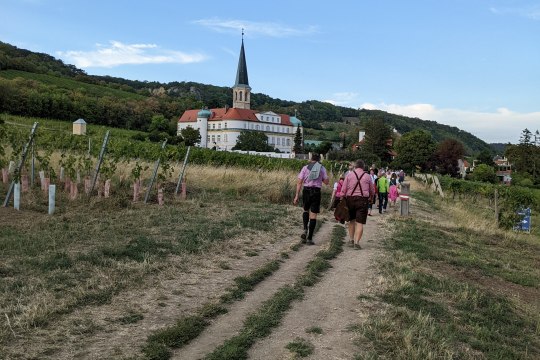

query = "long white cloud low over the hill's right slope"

[{"left": 360, "top": 103, "right": 540, "bottom": 143}]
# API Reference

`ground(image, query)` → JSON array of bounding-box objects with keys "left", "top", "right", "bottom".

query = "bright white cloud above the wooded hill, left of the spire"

[{"left": 57, "top": 41, "right": 207, "bottom": 68}]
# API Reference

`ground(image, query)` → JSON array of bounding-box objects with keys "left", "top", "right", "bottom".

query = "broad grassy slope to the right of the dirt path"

[{"left": 354, "top": 188, "right": 540, "bottom": 359}]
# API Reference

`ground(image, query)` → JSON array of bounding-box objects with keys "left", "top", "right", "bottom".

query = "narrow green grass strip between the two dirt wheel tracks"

[{"left": 206, "top": 226, "right": 345, "bottom": 360}]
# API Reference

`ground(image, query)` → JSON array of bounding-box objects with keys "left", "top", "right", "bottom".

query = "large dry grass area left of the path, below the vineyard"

[{"left": 0, "top": 164, "right": 312, "bottom": 357}]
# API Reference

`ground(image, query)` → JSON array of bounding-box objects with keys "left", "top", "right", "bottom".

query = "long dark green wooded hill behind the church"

[{"left": 0, "top": 42, "right": 489, "bottom": 152}]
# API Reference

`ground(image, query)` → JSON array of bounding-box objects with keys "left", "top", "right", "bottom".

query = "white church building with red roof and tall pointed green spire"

[{"left": 178, "top": 37, "right": 302, "bottom": 153}]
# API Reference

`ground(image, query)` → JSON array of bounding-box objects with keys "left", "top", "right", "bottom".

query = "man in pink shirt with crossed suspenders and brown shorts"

[{"left": 339, "top": 160, "right": 373, "bottom": 249}]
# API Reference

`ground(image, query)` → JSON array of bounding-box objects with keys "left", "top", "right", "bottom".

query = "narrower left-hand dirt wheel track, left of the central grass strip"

[{"left": 173, "top": 222, "right": 334, "bottom": 359}]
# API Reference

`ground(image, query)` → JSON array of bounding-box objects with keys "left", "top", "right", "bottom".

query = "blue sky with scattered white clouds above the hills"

[{"left": 0, "top": 0, "right": 540, "bottom": 142}]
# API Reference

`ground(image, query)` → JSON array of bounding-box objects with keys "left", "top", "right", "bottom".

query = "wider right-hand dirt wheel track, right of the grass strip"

[{"left": 249, "top": 214, "right": 384, "bottom": 360}]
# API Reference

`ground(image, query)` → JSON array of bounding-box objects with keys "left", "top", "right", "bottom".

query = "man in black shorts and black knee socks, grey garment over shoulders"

[{"left": 293, "top": 154, "right": 329, "bottom": 245}]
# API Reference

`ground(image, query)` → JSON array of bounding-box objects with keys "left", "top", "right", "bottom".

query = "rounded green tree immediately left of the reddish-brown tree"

[{"left": 392, "top": 130, "right": 437, "bottom": 173}]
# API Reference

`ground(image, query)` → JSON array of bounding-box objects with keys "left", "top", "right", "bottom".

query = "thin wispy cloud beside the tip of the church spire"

[{"left": 193, "top": 18, "right": 318, "bottom": 38}]
